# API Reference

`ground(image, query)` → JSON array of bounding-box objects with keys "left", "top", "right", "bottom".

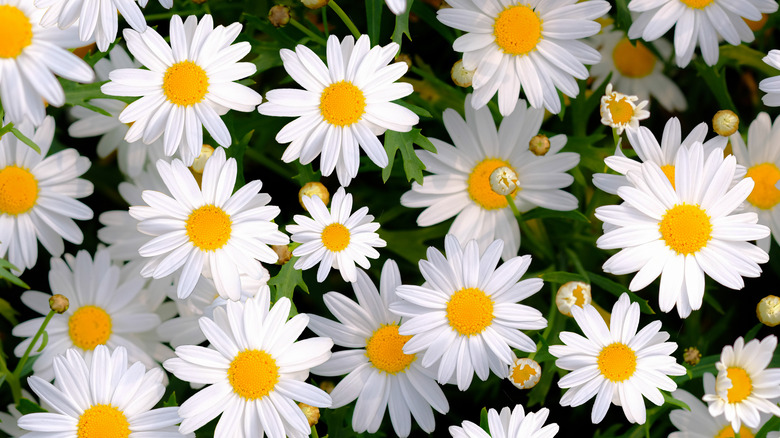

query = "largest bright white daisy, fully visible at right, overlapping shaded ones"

[{"left": 596, "top": 142, "right": 769, "bottom": 318}]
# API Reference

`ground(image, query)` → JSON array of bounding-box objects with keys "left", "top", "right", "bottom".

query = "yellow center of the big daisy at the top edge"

[{"left": 493, "top": 5, "right": 542, "bottom": 55}]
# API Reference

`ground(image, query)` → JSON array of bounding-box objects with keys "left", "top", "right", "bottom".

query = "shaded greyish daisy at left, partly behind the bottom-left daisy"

[{"left": 12, "top": 249, "right": 160, "bottom": 380}]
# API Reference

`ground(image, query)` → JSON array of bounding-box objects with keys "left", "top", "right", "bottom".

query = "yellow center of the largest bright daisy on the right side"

[{"left": 658, "top": 204, "right": 712, "bottom": 255}]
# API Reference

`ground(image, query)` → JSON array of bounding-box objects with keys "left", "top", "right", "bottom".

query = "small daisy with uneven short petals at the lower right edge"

[{"left": 703, "top": 335, "right": 780, "bottom": 432}]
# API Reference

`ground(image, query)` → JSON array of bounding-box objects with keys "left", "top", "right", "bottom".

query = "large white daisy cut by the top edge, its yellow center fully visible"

[{"left": 436, "top": 0, "right": 610, "bottom": 116}]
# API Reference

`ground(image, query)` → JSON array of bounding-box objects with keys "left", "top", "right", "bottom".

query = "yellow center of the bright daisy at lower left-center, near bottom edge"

[{"left": 228, "top": 350, "right": 279, "bottom": 400}]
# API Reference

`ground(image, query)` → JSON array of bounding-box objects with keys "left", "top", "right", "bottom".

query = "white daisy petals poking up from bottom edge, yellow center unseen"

[{"left": 450, "top": 405, "right": 559, "bottom": 438}]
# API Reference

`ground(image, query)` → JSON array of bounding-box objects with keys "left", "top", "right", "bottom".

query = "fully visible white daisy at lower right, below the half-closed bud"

[{"left": 550, "top": 293, "right": 685, "bottom": 424}]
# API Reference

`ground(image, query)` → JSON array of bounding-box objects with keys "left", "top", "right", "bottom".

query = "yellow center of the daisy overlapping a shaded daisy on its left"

[{"left": 447, "top": 287, "right": 493, "bottom": 336}]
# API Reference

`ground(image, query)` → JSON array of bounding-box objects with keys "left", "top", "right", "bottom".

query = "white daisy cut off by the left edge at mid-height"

[{"left": 0, "top": 118, "right": 93, "bottom": 272}]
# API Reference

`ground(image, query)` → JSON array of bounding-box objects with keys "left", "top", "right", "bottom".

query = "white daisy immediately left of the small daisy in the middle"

[{"left": 130, "top": 148, "right": 289, "bottom": 300}]
